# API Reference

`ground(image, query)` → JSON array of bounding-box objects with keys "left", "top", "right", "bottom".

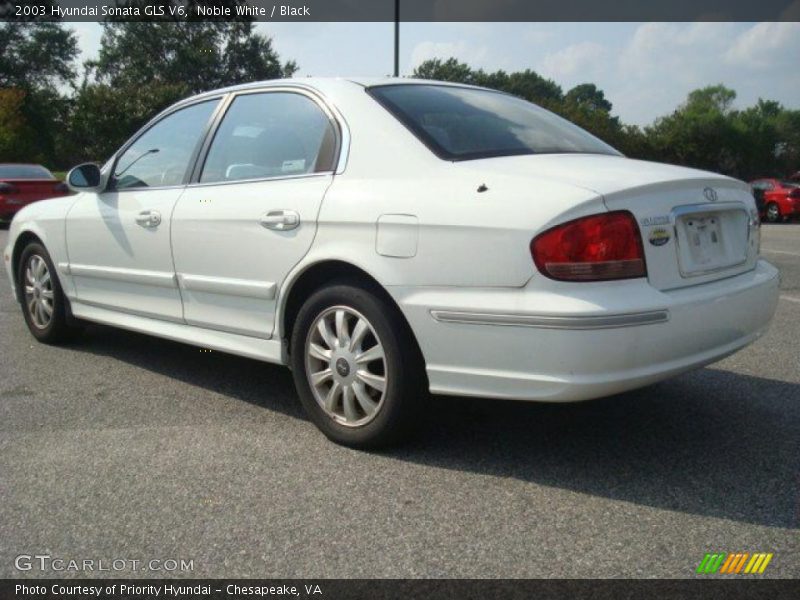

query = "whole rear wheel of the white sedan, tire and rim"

[{"left": 291, "top": 283, "right": 426, "bottom": 448}]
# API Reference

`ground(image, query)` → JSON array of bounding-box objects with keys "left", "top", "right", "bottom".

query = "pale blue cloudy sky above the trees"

[{"left": 70, "top": 22, "right": 800, "bottom": 125}]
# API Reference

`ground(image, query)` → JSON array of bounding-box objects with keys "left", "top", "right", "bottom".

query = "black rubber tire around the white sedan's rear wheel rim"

[{"left": 290, "top": 281, "right": 427, "bottom": 449}]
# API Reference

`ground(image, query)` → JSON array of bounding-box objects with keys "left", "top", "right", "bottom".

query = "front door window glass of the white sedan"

[{"left": 114, "top": 100, "right": 219, "bottom": 190}]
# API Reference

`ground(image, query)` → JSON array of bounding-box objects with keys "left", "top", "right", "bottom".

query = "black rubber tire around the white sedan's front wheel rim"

[{"left": 17, "top": 242, "right": 80, "bottom": 344}]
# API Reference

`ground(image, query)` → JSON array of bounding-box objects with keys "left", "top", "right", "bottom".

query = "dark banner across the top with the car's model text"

[{"left": 0, "top": 0, "right": 800, "bottom": 22}]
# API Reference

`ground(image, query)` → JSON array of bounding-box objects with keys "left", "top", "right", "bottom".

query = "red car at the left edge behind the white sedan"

[{"left": 0, "top": 163, "right": 69, "bottom": 222}]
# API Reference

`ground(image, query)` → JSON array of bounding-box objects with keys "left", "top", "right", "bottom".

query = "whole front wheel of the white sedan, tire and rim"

[{"left": 17, "top": 242, "right": 78, "bottom": 344}]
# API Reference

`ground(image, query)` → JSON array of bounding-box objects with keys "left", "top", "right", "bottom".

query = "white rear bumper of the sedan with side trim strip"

[{"left": 390, "top": 261, "right": 779, "bottom": 402}]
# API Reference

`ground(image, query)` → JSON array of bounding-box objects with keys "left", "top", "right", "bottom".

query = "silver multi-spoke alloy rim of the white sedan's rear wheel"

[{"left": 305, "top": 306, "right": 389, "bottom": 427}]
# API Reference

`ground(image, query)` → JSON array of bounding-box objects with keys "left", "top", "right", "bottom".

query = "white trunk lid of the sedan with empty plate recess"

[{"left": 456, "top": 154, "right": 760, "bottom": 290}]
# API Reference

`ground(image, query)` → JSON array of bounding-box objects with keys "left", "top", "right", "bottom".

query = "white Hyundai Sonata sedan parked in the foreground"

[{"left": 5, "top": 79, "right": 778, "bottom": 447}]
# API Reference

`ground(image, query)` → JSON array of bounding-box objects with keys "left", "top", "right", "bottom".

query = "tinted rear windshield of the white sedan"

[{"left": 368, "top": 84, "right": 619, "bottom": 160}]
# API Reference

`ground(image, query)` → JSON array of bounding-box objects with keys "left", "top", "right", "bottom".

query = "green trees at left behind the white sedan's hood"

[{"left": 0, "top": 21, "right": 297, "bottom": 169}]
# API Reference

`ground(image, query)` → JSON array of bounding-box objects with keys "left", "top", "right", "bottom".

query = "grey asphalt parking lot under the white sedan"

[{"left": 0, "top": 225, "right": 800, "bottom": 578}]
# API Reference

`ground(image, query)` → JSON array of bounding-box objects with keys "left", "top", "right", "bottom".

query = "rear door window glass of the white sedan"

[{"left": 200, "top": 92, "right": 336, "bottom": 183}]
